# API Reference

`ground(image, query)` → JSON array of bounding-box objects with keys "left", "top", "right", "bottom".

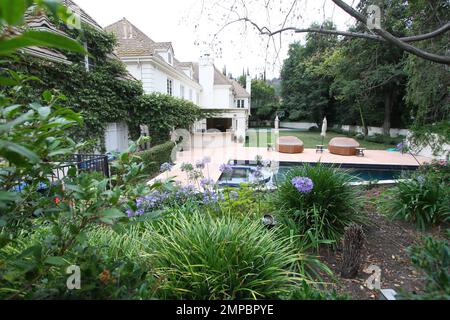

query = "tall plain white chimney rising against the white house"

[{"left": 198, "top": 54, "right": 214, "bottom": 108}]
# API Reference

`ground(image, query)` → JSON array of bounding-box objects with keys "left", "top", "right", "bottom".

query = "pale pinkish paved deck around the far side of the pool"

[{"left": 150, "top": 143, "right": 431, "bottom": 185}]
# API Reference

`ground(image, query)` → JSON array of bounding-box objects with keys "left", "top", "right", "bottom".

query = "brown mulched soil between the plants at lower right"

[{"left": 320, "top": 187, "right": 446, "bottom": 300}]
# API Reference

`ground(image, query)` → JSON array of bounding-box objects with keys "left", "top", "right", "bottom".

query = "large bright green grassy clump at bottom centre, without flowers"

[{"left": 152, "top": 213, "right": 300, "bottom": 300}]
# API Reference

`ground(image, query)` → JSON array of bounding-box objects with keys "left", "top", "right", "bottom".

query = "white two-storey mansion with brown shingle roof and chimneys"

[{"left": 105, "top": 18, "right": 251, "bottom": 140}]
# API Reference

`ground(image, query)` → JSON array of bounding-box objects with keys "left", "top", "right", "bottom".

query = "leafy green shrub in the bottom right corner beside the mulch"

[{"left": 402, "top": 230, "right": 450, "bottom": 300}]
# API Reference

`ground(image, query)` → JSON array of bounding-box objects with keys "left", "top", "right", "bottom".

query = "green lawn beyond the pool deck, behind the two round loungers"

[{"left": 246, "top": 129, "right": 395, "bottom": 150}]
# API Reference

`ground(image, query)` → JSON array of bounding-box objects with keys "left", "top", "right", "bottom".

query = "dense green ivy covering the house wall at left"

[{"left": 9, "top": 22, "right": 206, "bottom": 150}]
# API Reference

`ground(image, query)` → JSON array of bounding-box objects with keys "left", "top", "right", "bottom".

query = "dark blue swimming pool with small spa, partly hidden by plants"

[{"left": 218, "top": 160, "right": 419, "bottom": 187}]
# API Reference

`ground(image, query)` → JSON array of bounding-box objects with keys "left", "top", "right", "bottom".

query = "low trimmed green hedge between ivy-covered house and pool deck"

[{"left": 137, "top": 141, "right": 175, "bottom": 176}]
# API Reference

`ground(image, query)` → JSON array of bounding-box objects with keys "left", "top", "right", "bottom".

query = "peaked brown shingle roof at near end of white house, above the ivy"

[{"left": 105, "top": 18, "right": 173, "bottom": 58}]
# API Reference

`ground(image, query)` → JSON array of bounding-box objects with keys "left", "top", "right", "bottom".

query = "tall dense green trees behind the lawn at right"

[{"left": 281, "top": 0, "right": 450, "bottom": 146}]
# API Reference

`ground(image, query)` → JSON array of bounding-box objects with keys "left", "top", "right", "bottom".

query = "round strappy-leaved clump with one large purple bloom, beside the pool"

[{"left": 273, "top": 164, "right": 365, "bottom": 242}]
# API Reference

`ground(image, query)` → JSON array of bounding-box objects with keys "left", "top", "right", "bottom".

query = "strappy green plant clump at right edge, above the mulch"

[{"left": 381, "top": 174, "right": 450, "bottom": 230}]
